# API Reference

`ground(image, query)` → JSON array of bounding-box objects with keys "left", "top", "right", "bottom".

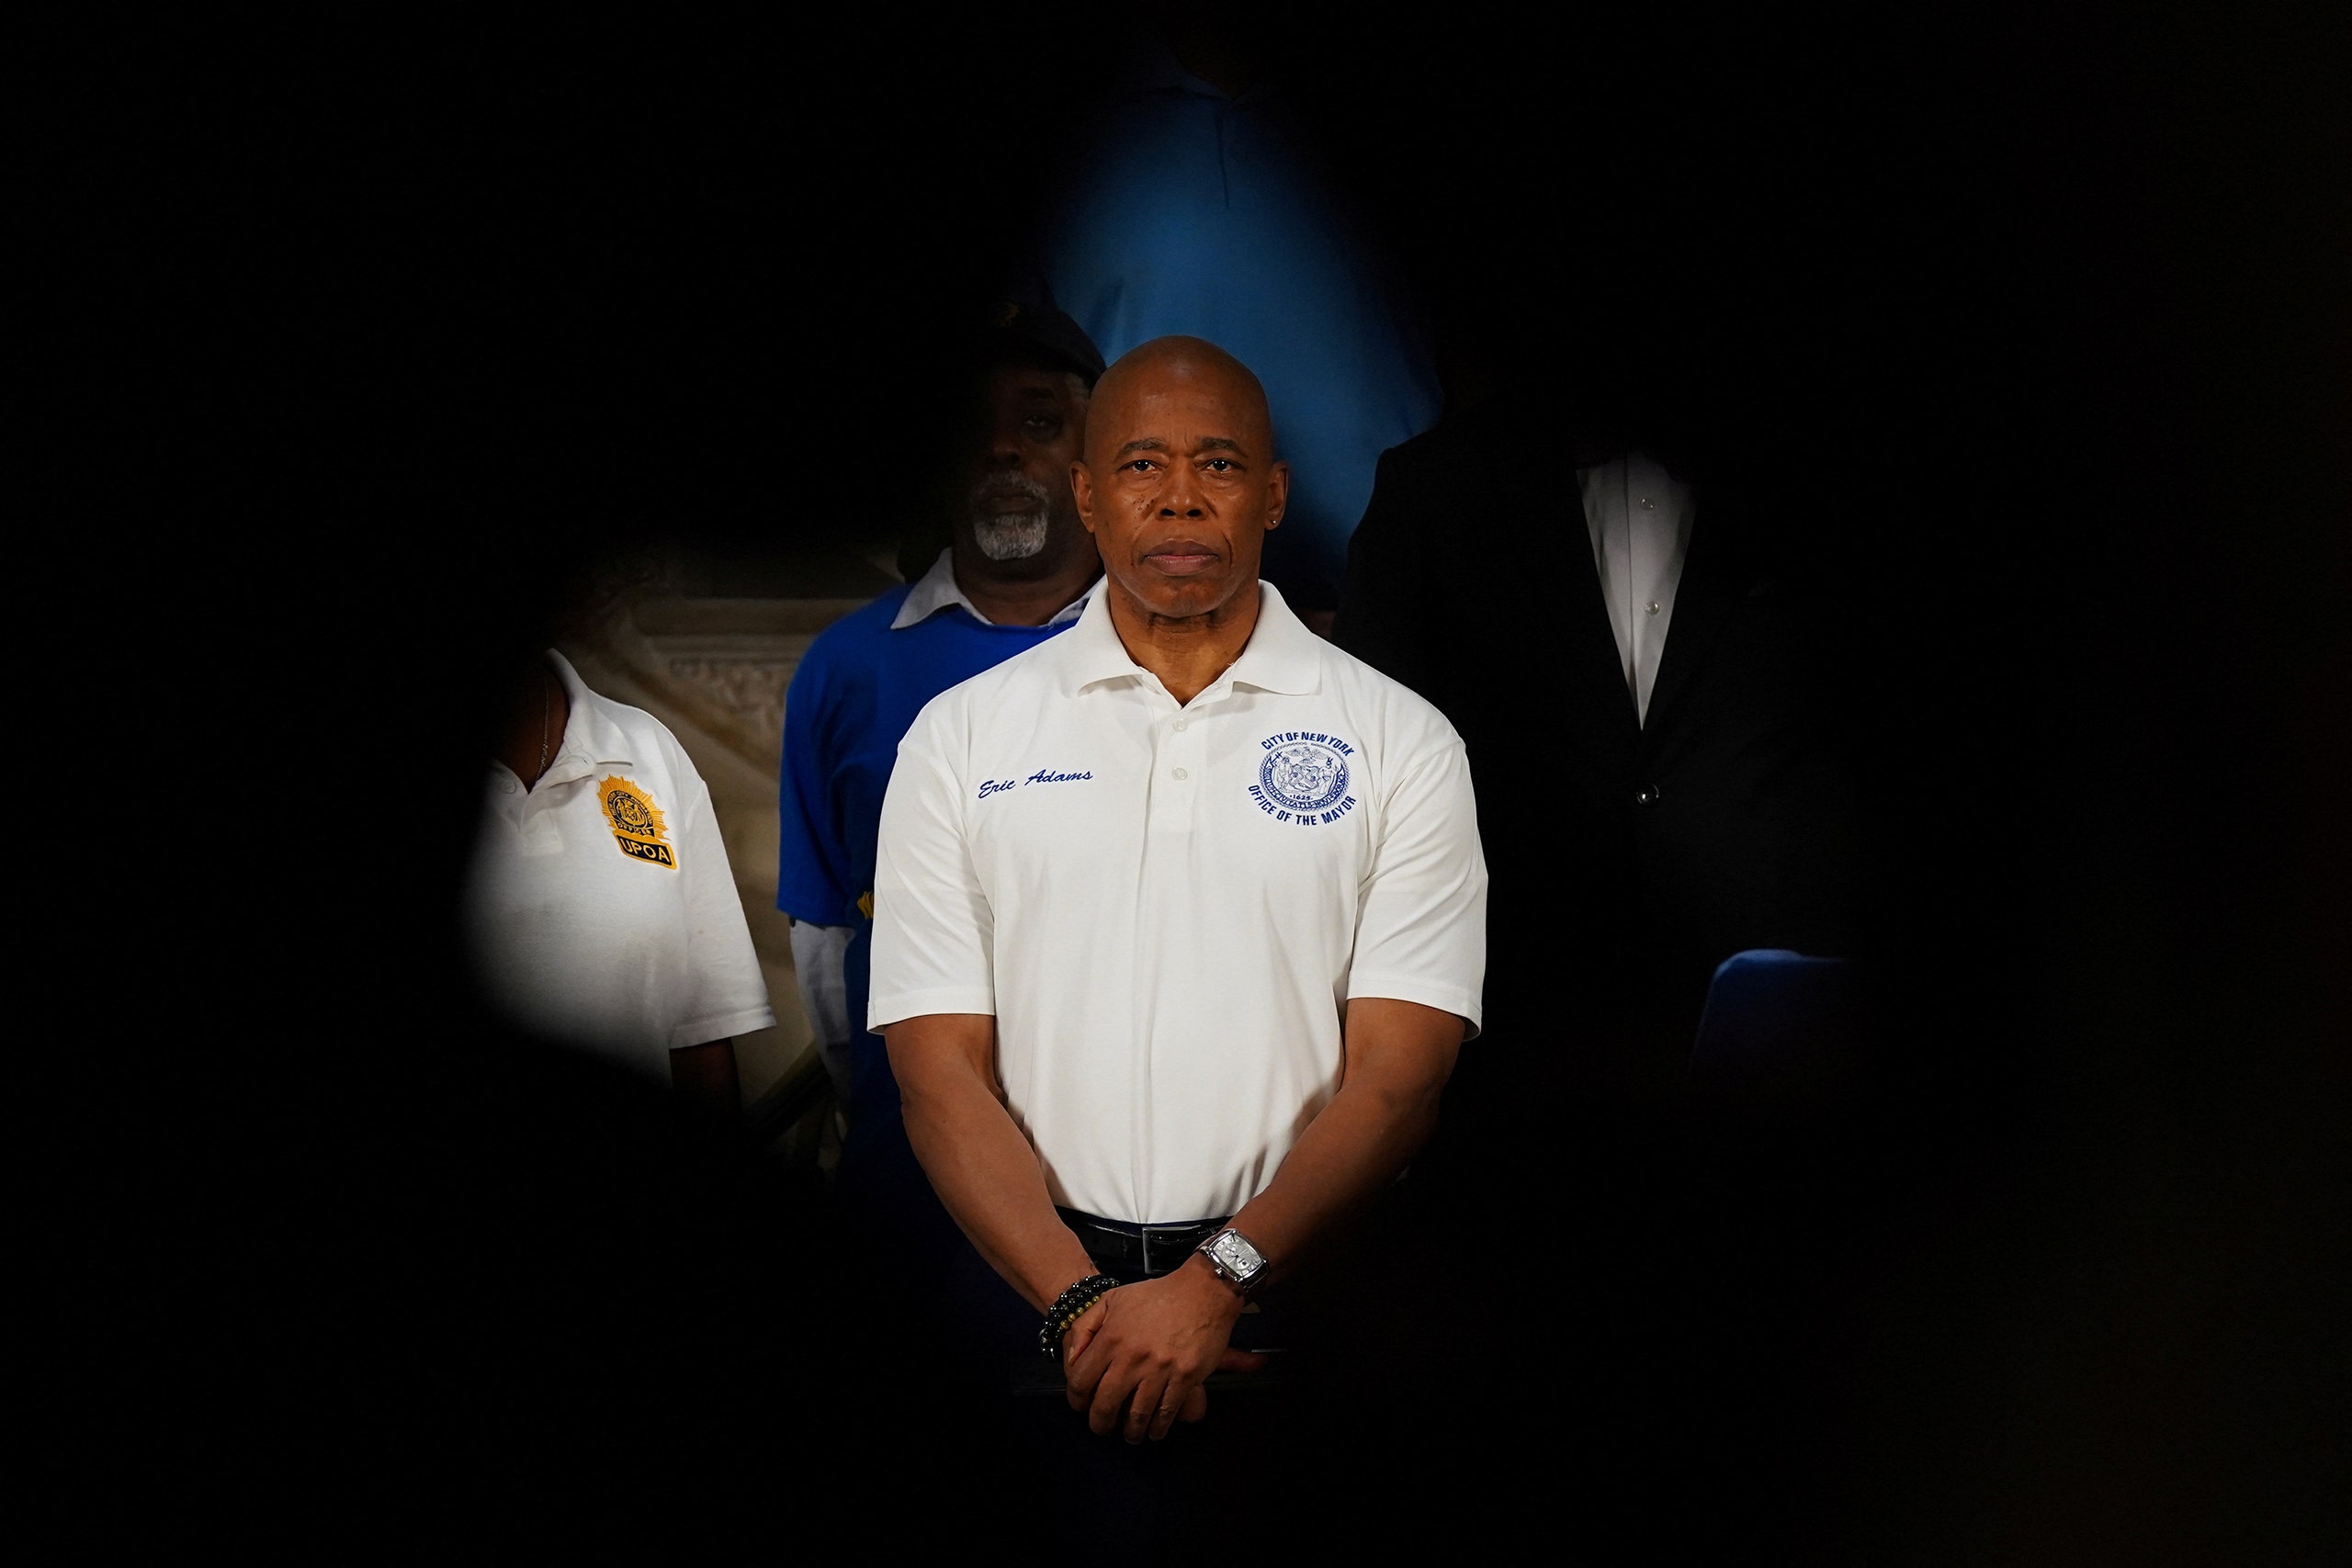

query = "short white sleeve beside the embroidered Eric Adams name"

[{"left": 865, "top": 707, "right": 997, "bottom": 1030}]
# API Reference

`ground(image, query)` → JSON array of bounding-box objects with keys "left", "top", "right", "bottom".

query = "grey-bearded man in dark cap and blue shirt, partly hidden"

[{"left": 776, "top": 306, "right": 1103, "bottom": 1253}]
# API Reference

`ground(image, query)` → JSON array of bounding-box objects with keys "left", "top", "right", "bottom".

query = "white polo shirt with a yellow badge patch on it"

[{"left": 466, "top": 651, "right": 776, "bottom": 1081}]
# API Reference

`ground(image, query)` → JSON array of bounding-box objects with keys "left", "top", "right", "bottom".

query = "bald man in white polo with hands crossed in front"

[{"left": 868, "top": 339, "right": 1487, "bottom": 1443}]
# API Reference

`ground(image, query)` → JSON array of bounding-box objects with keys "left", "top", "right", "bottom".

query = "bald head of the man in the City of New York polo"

[{"left": 1070, "top": 339, "right": 1289, "bottom": 626}]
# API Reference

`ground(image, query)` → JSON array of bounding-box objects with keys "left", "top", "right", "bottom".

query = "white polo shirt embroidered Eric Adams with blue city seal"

[{"left": 868, "top": 583, "right": 1487, "bottom": 1224}]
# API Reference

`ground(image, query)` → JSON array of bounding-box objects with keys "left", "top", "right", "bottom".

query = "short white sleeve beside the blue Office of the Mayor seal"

[{"left": 1348, "top": 740, "right": 1487, "bottom": 1037}]
